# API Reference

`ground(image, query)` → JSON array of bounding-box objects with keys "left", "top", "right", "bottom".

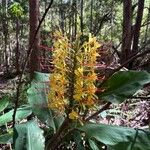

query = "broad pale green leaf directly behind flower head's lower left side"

[{"left": 27, "top": 72, "right": 64, "bottom": 132}]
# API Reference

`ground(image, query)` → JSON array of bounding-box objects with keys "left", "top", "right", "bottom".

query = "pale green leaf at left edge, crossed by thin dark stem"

[{"left": 0, "top": 106, "right": 32, "bottom": 126}]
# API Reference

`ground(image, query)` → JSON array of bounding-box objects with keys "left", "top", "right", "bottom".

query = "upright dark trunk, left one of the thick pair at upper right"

[{"left": 121, "top": 0, "right": 132, "bottom": 67}]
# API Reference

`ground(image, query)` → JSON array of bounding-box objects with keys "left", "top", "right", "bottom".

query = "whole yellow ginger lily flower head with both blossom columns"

[{"left": 48, "top": 32, "right": 100, "bottom": 121}]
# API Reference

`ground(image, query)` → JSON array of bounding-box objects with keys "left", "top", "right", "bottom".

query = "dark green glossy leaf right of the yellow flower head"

[{"left": 98, "top": 71, "right": 150, "bottom": 103}]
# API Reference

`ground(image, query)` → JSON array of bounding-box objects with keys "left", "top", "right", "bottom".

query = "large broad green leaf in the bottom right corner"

[{"left": 78, "top": 123, "right": 150, "bottom": 150}]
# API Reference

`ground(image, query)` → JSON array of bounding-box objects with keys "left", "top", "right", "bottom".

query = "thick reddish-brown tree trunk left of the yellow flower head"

[{"left": 29, "top": 0, "right": 40, "bottom": 79}]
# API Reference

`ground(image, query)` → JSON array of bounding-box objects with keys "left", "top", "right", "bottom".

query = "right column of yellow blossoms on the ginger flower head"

[{"left": 75, "top": 35, "right": 100, "bottom": 106}]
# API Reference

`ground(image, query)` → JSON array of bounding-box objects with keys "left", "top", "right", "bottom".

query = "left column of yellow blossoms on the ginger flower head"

[{"left": 48, "top": 32, "right": 69, "bottom": 112}]
